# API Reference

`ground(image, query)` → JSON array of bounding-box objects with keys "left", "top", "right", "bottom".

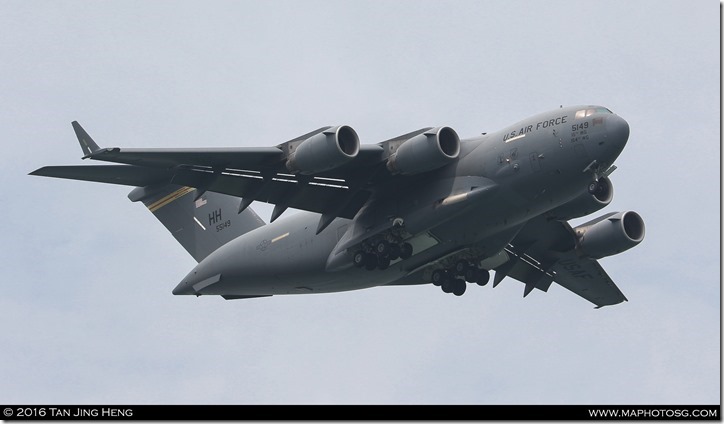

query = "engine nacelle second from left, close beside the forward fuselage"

[{"left": 387, "top": 127, "right": 460, "bottom": 175}]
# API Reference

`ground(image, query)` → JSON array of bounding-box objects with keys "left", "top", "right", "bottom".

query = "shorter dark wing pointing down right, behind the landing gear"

[{"left": 493, "top": 217, "right": 628, "bottom": 308}]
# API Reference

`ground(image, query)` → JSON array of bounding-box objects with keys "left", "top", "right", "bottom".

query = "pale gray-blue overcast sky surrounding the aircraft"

[{"left": 0, "top": 0, "right": 721, "bottom": 404}]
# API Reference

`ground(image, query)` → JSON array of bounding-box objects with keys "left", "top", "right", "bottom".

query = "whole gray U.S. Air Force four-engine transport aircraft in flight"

[{"left": 31, "top": 106, "right": 645, "bottom": 307}]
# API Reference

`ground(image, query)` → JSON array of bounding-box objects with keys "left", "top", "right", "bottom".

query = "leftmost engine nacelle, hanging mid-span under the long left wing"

[{"left": 287, "top": 125, "right": 359, "bottom": 175}]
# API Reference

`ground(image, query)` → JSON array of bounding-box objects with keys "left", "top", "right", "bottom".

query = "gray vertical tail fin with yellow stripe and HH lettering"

[{"left": 128, "top": 184, "right": 264, "bottom": 262}]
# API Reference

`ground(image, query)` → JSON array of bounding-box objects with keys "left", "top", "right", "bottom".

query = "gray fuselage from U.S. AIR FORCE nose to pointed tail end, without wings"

[{"left": 174, "top": 106, "right": 629, "bottom": 296}]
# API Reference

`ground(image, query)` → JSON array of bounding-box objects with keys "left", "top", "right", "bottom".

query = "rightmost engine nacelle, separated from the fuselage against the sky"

[{"left": 574, "top": 211, "right": 646, "bottom": 259}]
